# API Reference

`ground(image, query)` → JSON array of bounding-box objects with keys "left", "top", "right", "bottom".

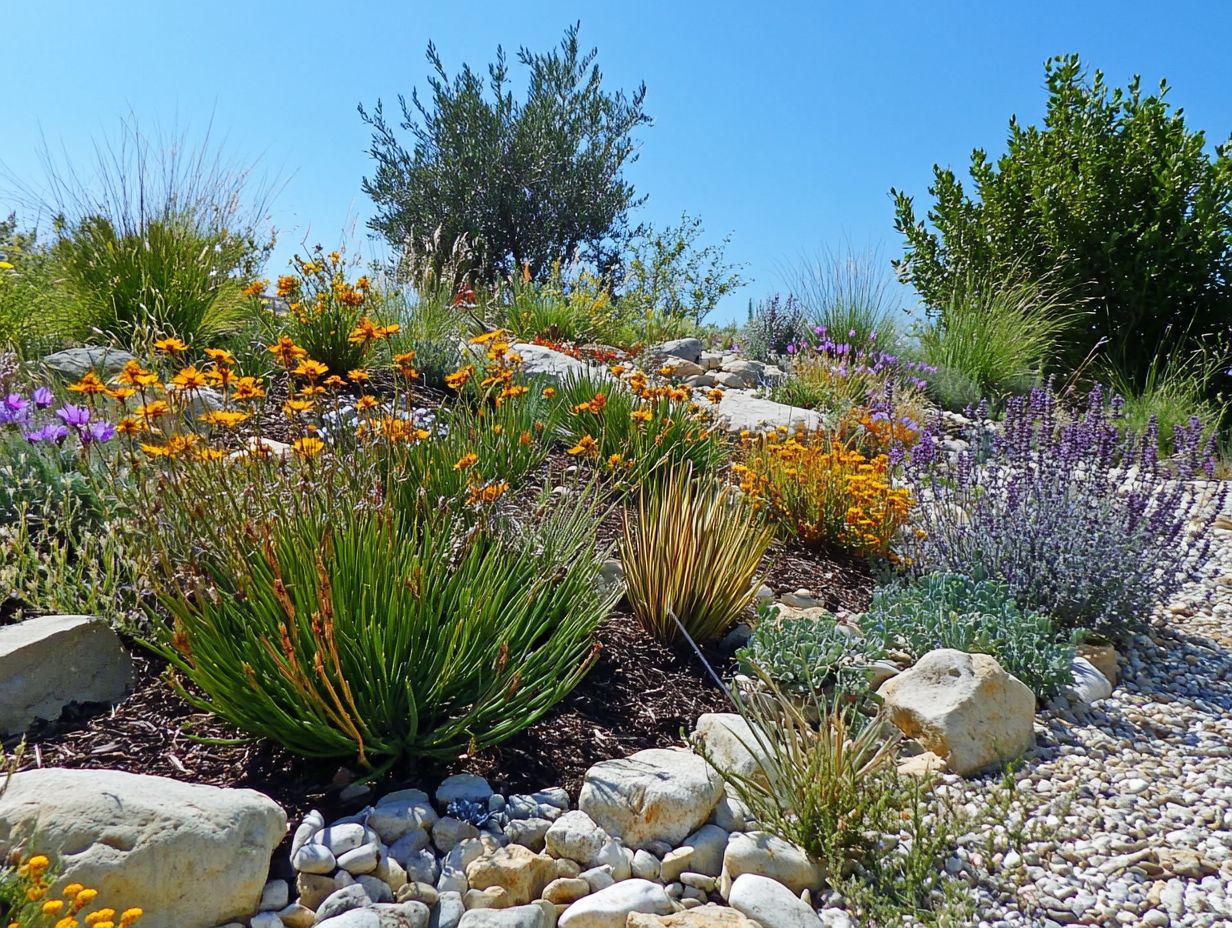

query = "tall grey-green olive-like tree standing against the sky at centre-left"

[{"left": 360, "top": 23, "right": 650, "bottom": 280}]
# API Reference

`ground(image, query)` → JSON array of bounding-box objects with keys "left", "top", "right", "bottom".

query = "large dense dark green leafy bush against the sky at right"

[{"left": 892, "top": 55, "right": 1232, "bottom": 385}]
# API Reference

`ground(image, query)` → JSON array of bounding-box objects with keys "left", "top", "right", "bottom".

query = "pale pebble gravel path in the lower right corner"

[{"left": 946, "top": 517, "right": 1232, "bottom": 928}]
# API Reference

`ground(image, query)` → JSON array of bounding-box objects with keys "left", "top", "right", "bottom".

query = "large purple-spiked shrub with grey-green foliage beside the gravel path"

[{"left": 904, "top": 387, "right": 1225, "bottom": 635}]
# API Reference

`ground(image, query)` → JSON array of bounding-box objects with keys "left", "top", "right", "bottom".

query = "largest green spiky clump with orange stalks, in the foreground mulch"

[{"left": 156, "top": 485, "right": 611, "bottom": 767}]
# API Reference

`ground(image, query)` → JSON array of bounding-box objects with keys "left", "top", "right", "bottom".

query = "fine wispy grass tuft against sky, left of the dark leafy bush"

[{"left": 787, "top": 246, "right": 902, "bottom": 350}]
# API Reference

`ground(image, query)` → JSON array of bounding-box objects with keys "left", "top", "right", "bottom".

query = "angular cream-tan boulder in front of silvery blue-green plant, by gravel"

[{"left": 878, "top": 648, "right": 1035, "bottom": 776}]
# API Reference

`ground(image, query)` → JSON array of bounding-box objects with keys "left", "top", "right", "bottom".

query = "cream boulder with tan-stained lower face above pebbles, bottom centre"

[{"left": 578, "top": 748, "right": 723, "bottom": 848}]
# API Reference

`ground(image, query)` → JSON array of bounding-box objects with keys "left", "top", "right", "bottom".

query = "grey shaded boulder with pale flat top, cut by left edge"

[{"left": 0, "top": 615, "right": 133, "bottom": 735}]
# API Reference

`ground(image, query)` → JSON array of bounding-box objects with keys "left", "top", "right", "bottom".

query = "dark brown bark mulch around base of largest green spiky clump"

[{"left": 9, "top": 615, "right": 727, "bottom": 817}]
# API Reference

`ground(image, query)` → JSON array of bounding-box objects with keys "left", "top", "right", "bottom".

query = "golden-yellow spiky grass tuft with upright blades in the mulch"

[{"left": 620, "top": 466, "right": 774, "bottom": 643}]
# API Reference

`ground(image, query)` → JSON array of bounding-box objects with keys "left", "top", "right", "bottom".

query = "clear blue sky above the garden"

[{"left": 0, "top": 0, "right": 1232, "bottom": 318}]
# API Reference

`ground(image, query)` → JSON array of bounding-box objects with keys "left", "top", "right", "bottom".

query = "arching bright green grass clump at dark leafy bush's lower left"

[{"left": 920, "top": 275, "right": 1077, "bottom": 409}]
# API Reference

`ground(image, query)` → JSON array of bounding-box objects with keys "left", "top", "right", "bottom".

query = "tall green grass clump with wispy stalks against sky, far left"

[{"left": 19, "top": 115, "right": 272, "bottom": 348}]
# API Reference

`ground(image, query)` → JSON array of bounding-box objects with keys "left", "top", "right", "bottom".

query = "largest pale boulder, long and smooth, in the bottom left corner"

[{"left": 0, "top": 768, "right": 287, "bottom": 928}]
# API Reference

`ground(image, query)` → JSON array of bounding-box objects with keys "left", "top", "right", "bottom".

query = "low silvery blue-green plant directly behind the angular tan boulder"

[{"left": 862, "top": 573, "right": 1074, "bottom": 700}]
